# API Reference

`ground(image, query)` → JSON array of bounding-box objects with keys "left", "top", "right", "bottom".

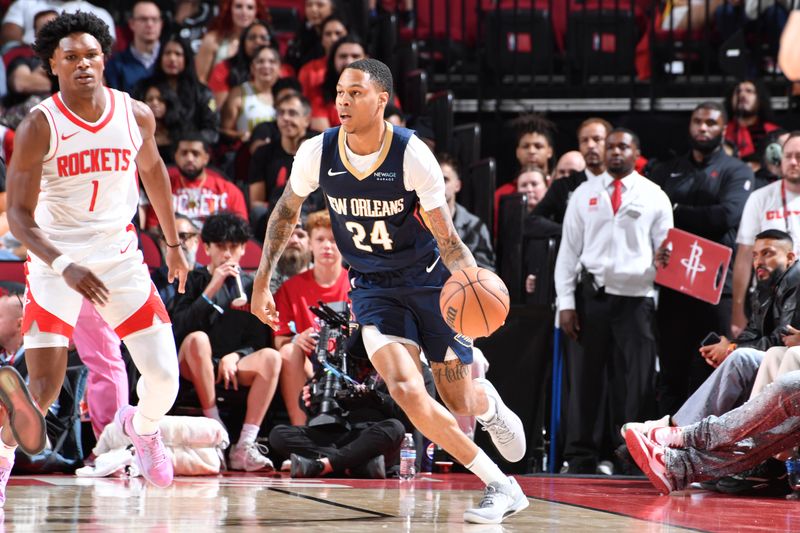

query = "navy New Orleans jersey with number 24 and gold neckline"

[{"left": 319, "top": 126, "right": 438, "bottom": 274}]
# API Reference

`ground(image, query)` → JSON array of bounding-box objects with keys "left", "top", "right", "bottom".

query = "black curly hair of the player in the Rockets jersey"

[{"left": 33, "top": 11, "right": 114, "bottom": 75}]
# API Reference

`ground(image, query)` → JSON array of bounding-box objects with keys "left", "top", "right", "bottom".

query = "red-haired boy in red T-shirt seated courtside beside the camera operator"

[{"left": 275, "top": 211, "right": 350, "bottom": 426}]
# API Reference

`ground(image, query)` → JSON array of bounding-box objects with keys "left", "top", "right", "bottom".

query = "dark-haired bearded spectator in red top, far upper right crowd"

[{"left": 725, "top": 80, "right": 780, "bottom": 161}]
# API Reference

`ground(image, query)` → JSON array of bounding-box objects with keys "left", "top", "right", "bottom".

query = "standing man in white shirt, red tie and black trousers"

[{"left": 555, "top": 128, "right": 672, "bottom": 474}]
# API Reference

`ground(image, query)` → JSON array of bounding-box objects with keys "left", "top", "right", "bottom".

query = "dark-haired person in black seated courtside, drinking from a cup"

[{"left": 170, "top": 213, "right": 281, "bottom": 471}]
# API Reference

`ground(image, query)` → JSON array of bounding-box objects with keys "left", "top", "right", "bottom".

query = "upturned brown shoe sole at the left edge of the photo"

[{"left": 0, "top": 366, "right": 47, "bottom": 455}]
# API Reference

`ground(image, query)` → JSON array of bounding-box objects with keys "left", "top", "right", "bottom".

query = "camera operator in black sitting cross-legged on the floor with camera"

[{"left": 269, "top": 326, "right": 434, "bottom": 479}]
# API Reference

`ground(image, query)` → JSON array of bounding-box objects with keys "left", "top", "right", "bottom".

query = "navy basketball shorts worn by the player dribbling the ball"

[{"left": 350, "top": 251, "right": 472, "bottom": 364}]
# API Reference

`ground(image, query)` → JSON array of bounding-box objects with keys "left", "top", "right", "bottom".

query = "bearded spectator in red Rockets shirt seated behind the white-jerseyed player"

[{"left": 145, "top": 132, "right": 248, "bottom": 229}]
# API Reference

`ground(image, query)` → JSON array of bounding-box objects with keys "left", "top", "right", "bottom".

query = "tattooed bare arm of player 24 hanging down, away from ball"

[{"left": 250, "top": 182, "right": 305, "bottom": 329}]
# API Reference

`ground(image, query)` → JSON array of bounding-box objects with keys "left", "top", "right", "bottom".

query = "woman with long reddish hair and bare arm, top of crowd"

[{"left": 195, "top": 0, "right": 270, "bottom": 83}]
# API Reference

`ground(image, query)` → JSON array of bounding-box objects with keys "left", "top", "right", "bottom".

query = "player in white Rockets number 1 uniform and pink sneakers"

[{"left": 5, "top": 12, "right": 188, "bottom": 493}]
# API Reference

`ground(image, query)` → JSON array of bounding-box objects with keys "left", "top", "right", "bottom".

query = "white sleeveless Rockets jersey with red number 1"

[{"left": 32, "top": 88, "right": 142, "bottom": 244}]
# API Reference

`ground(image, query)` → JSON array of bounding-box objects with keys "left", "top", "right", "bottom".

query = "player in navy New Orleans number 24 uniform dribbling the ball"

[{"left": 252, "top": 59, "right": 528, "bottom": 523}]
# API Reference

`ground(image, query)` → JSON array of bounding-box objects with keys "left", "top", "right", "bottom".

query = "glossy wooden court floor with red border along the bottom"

[{"left": 2, "top": 474, "right": 800, "bottom": 533}]
